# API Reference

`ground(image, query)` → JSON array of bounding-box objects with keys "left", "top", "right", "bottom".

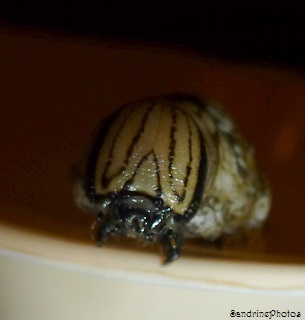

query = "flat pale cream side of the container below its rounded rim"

[{"left": 0, "top": 252, "right": 305, "bottom": 320}]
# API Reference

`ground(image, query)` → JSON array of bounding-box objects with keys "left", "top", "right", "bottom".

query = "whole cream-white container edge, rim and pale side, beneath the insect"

[{"left": 0, "top": 225, "right": 305, "bottom": 320}]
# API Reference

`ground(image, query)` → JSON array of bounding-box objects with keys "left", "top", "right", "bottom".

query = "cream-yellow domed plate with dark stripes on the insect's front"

[{"left": 86, "top": 96, "right": 207, "bottom": 217}]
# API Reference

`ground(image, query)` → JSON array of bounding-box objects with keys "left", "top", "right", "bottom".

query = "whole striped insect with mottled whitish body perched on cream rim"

[{"left": 75, "top": 94, "right": 270, "bottom": 264}]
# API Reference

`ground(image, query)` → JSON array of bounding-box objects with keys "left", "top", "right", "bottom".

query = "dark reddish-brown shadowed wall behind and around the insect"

[{"left": 0, "top": 29, "right": 305, "bottom": 259}]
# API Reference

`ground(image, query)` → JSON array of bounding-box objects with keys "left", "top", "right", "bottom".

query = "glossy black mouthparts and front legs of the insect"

[{"left": 93, "top": 191, "right": 183, "bottom": 264}]
